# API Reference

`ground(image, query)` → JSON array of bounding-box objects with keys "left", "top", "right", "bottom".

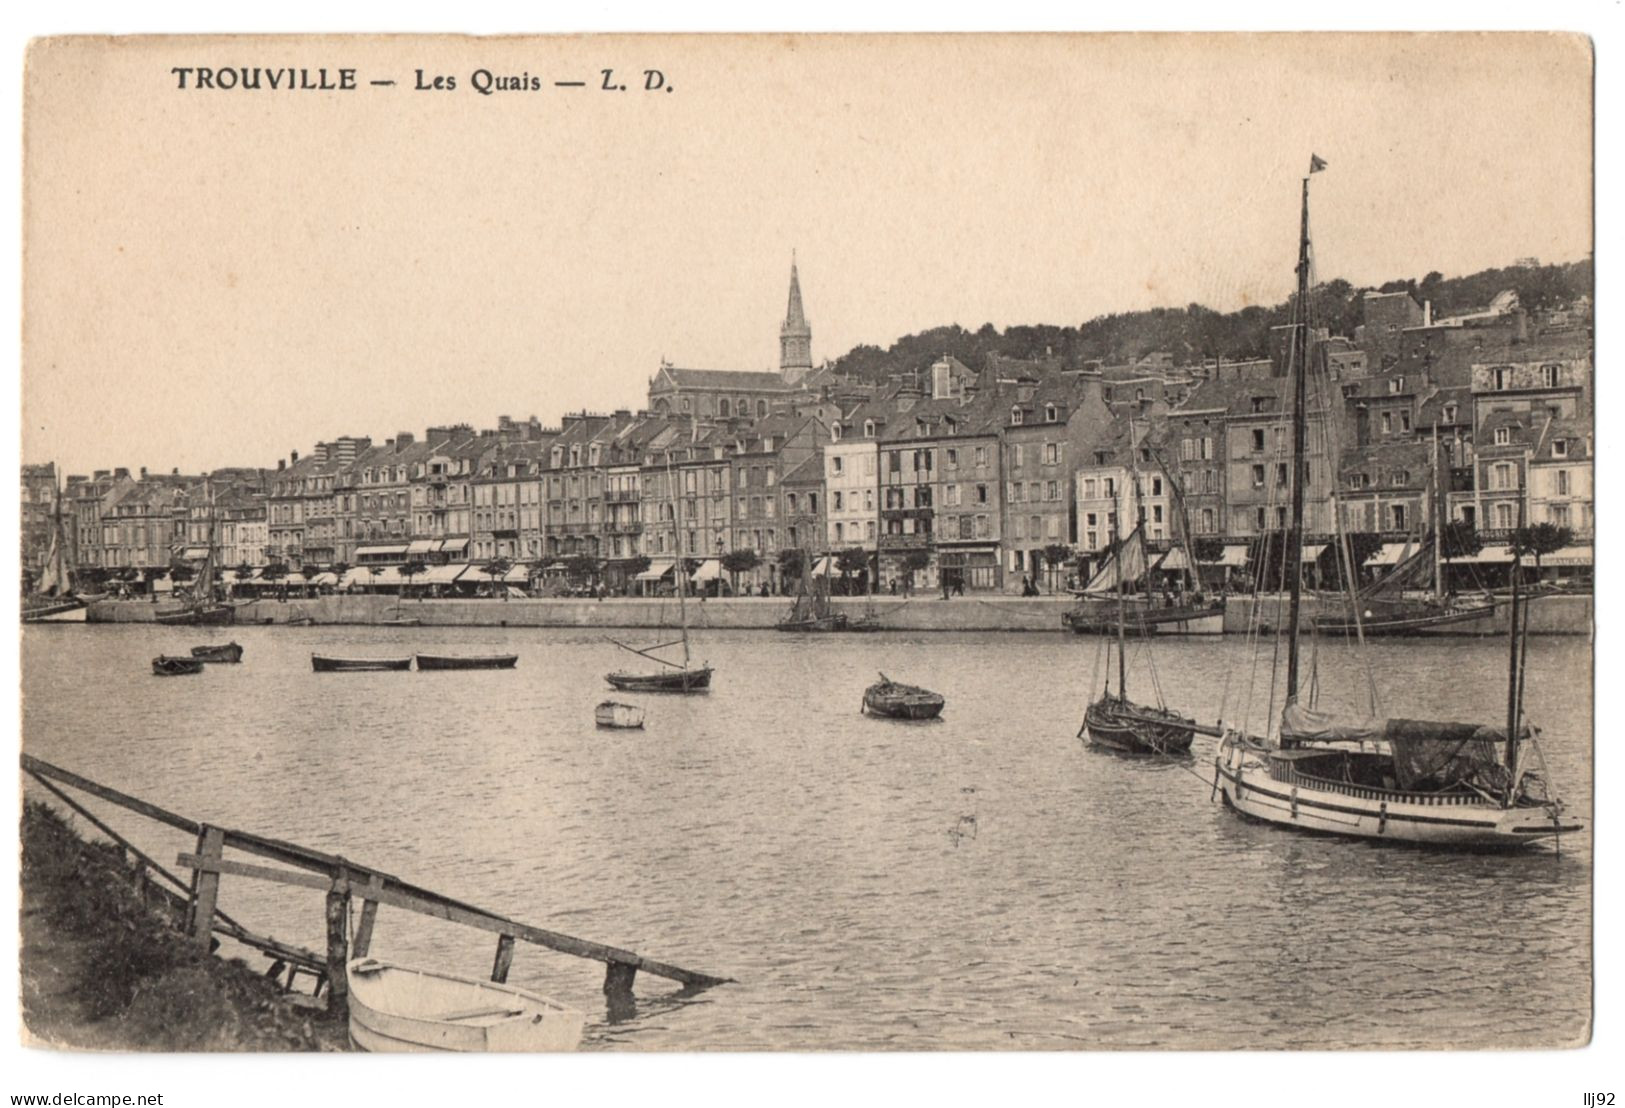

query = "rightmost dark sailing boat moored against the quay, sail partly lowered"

[{"left": 1315, "top": 427, "right": 1500, "bottom": 635}]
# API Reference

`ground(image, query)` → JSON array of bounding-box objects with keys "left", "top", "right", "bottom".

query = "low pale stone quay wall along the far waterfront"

[{"left": 86, "top": 595, "right": 1593, "bottom": 635}]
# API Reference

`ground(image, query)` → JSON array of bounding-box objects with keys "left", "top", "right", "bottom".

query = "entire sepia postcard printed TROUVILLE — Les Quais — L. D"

[{"left": 6, "top": 21, "right": 1610, "bottom": 1103}]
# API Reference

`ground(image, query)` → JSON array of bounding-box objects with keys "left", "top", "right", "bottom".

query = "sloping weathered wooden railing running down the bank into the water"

[{"left": 21, "top": 754, "right": 731, "bottom": 1014}]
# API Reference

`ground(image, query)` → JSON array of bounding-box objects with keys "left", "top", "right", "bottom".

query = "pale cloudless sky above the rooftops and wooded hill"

[{"left": 23, "top": 34, "right": 1591, "bottom": 473}]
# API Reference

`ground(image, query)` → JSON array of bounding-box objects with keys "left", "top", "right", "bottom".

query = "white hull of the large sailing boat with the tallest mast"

[{"left": 1214, "top": 738, "right": 1584, "bottom": 850}]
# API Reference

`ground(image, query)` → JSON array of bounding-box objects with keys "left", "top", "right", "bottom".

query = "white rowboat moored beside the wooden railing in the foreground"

[{"left": 346, "top": 959, "right": 587, "bottom": 1053}]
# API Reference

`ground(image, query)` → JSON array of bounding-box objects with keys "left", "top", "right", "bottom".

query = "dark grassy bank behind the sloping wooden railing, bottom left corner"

[{"left": 21, "top": 801, "right": 345, "bottom": 1051}]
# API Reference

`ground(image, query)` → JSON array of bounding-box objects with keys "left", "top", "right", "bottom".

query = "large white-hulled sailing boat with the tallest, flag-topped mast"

[{"left": 1214, "top": 159, "right": 1583, "bottom": 848}]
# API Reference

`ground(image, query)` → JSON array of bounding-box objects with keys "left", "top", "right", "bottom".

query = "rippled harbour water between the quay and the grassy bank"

[{"left": 23, "top": 624, "right": 1593, "bottom": 1050}]
